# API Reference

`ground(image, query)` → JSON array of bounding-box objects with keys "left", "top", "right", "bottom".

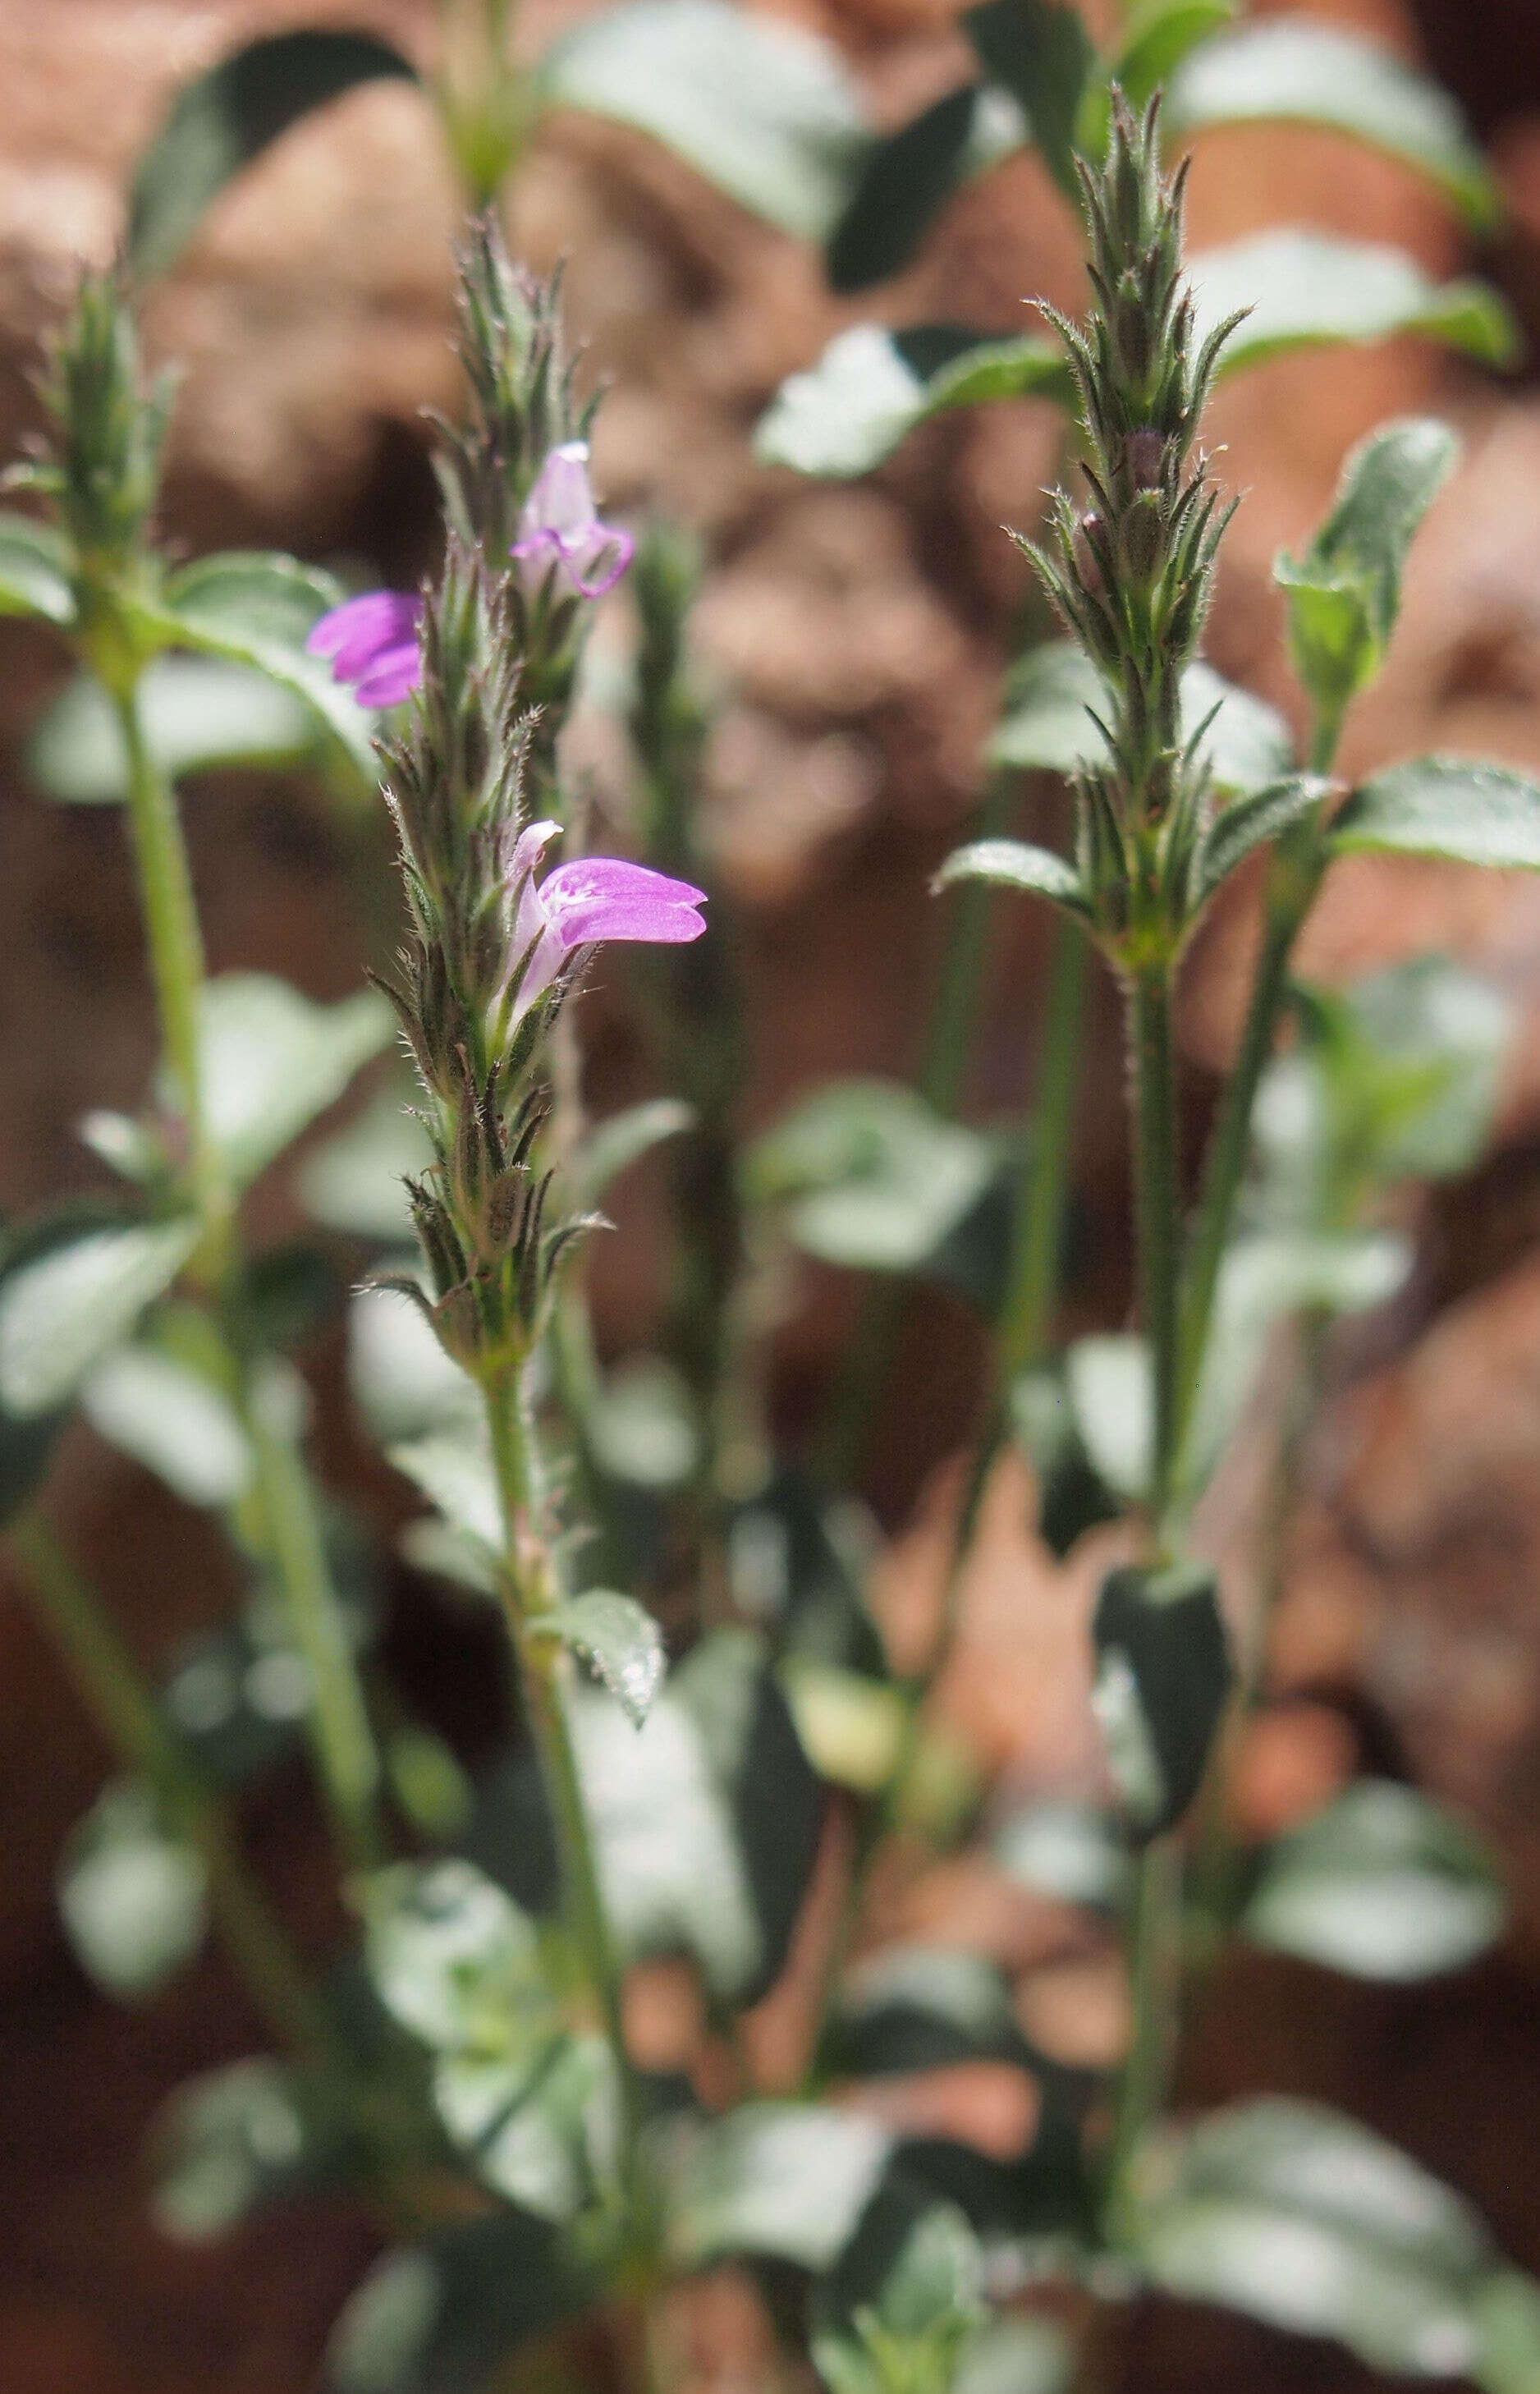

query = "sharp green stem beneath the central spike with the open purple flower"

[{"left": 484, "top": 1364, "right": 642, "bottom": 2227}]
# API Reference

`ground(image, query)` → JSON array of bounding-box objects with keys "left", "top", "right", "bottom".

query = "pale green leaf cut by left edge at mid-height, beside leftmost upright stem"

[{"left": 0, "top": 1213, "right": 199, "bottom": 1422}]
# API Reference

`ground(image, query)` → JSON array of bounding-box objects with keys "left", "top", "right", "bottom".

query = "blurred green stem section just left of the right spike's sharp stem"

[{"left": 994, "top": 922, "right": 1089, "bottom": 1391}]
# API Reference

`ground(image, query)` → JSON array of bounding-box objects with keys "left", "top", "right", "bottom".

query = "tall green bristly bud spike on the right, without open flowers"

[{"left": 1023, "top": 96, "right": 1231, "bottom": 962}]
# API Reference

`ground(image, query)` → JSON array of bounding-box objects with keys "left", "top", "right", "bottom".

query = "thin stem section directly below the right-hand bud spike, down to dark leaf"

[{"left": 1128, "top": 962, "right": 1180, "bottom": 1525}]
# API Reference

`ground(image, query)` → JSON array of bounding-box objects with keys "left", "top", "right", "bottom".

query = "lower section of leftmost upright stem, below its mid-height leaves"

[{"left": 240, "top": 1374, "right": 383, "bottom": 1869}]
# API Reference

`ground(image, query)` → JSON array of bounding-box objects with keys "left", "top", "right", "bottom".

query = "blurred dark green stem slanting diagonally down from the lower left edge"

[{"left": 10, "top": 1513, "right": 333, "bottom": 2062}]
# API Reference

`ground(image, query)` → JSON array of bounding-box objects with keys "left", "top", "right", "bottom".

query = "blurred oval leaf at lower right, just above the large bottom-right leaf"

[{"left": 1243, "top": 1779, "right": 1504, "bottom": 1980}]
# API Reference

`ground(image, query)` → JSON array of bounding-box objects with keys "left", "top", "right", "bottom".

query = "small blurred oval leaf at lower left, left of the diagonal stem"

[{"left": 57, "top": 1779, "right": 209, "bottom": 2002}]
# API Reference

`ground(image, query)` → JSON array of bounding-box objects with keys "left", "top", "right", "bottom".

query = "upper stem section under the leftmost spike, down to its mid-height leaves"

[{"left": 108, "top": 675, "right": 230, "bottom": 1278}]
